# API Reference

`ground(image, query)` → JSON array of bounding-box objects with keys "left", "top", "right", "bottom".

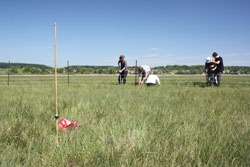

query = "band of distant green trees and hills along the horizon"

[{"left": 0, "top": 63, "right": 250, "bottom": 74}]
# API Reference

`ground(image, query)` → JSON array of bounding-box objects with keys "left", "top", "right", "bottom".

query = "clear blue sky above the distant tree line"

[{"left": 0, "top": 0, "right": 250, "bottom": 67}]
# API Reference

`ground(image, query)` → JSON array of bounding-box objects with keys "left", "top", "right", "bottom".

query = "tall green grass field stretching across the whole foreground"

[{"left": 0, "top": 75, "right": 250, "bottom": 167}]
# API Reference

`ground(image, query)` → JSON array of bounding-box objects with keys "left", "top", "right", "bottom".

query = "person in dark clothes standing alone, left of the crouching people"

[{"left": 118, "top": 55, "right": 128, "bottom": 85}]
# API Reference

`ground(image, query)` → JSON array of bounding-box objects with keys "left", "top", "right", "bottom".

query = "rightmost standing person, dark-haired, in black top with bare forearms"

[{"left": 212, "top": 52, "right": 224, "bottom": 87}]
